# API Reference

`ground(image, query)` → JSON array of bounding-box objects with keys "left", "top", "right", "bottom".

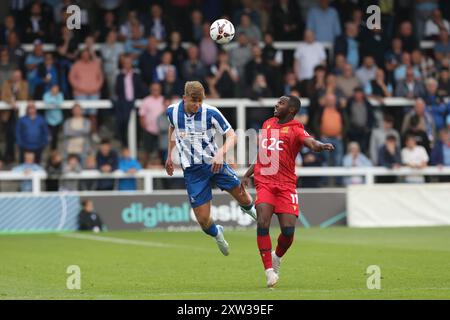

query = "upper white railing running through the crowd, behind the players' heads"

[{"left": 0, "top": 97, "right": 414, "bottom": 157}]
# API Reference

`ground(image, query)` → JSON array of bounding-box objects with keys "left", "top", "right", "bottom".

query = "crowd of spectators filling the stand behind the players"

[{"left": 0, "top": 0, "right": 450, "bottom": 191}]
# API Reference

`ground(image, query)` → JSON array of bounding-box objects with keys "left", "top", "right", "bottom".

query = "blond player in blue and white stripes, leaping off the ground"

[{"left": 166, "top": 81, "right": 256, "bottom": 256}]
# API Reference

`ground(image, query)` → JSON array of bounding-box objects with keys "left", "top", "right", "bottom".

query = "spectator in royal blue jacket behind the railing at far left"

[{"left": 16, "top": 101, "right": 48, "bottom": 163}]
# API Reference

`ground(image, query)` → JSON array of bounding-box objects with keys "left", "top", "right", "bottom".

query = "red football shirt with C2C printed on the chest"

[{"left": 254, "top": 117, "right": 310, "bottom": 186}]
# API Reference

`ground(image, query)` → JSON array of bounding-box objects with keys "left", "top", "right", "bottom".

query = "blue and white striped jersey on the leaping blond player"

[{"left": 166, "top": 100, "right": 231, "bottom": 169}]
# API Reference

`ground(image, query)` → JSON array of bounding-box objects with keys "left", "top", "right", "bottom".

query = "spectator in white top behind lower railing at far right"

[{"left": 402, "top": 135, "right": 429, "bottom": 183}]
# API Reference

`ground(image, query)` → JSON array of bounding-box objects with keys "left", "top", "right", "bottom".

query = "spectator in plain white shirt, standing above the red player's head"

[{"left": 294, "top": 30, "right": 327, "bottom": 81}]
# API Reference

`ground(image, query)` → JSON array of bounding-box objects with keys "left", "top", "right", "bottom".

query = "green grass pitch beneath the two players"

[{"left": 0, "top": 227, "right": 450, "bottom": 300}]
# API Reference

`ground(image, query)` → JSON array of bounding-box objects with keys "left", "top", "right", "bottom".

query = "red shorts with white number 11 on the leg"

[{"left": 255, "top": 183, "right": 299, "bottom": 217}]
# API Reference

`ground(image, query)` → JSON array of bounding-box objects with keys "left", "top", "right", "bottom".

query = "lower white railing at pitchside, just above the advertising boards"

[{"left": 0, "top": 167, "right": 450, "bottom": 194}]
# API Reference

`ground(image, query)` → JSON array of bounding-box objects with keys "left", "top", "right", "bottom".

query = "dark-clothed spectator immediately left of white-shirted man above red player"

[{"left": 262, "top": 32, "right": 283, "bottom": 96}]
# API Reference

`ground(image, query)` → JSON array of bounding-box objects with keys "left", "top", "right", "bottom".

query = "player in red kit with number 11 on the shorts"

[{"left": 241, "top": 96, "right": 334, "bottom": 288}]
